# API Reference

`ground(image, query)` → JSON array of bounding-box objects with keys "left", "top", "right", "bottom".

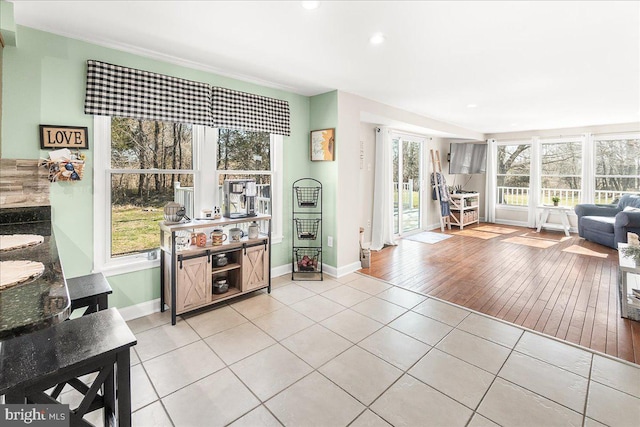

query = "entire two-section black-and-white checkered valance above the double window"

[{"left": 84, "top": 60, "right": 290, "bottom": 135}]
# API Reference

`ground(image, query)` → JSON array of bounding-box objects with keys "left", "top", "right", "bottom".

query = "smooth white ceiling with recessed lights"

[{"left": 6, "top": 0, "right": 640, "bottom": 133}]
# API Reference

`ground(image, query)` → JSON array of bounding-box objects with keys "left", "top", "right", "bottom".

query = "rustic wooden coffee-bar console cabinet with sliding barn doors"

[{"left": 160, "top": 215, "right": 271, "bottom": 325}]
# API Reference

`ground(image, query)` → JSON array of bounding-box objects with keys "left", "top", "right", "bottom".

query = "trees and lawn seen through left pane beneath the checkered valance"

[{"left": 107, "top": 117, "right": 194, "bottom": 257}]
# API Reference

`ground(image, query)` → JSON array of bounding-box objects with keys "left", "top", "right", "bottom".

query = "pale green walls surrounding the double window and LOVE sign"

[{"left": 1, "top": 26, "right": 318, "bottom": 307}]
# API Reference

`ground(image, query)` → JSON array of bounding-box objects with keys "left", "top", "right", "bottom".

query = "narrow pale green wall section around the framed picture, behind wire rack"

[{"left": 300, "top": 91, "right": 340, "bottom": 266}]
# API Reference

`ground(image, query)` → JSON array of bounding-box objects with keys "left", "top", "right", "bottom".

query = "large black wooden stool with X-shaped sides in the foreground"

[{"left": 0, "top": 308, "right": 137, "bottom": 427}]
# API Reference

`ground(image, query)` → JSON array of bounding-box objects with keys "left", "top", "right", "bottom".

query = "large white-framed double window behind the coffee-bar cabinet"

[{"left": 94, "top": 116, "right": 282, "bottom": 274}]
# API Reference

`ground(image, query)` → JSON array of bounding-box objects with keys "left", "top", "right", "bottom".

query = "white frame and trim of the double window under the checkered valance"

[{"left": 93, "top": 116, "right": 283, "bottom": 276}]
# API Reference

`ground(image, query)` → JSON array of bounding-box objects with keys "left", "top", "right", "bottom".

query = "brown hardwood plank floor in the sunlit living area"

[{"left": 360, "top": 224, "right": 640, "bottom": 364}]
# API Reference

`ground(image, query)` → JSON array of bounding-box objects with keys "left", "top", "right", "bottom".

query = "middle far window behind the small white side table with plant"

[{"left": 540, "top": 140, "right": 582, "bottom": 206}]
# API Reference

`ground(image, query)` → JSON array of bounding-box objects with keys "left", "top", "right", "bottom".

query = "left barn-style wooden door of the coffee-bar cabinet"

[{"left": 176, "top": 256, "right": 211, "bottom": 312}]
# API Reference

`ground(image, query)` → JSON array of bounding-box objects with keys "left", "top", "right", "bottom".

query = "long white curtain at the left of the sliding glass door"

[{"left": 371, "top": 127, "right": 396, "bottom": 251}]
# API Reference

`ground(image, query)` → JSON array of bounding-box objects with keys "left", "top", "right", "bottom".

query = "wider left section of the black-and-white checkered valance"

[{"left": 84, "top": 60, "right": 211, "bottom": 126}]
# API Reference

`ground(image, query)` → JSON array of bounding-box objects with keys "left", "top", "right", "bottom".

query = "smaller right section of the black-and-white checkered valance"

[{"left": 211, "top": 87, "right": 290, "bottom": 135}]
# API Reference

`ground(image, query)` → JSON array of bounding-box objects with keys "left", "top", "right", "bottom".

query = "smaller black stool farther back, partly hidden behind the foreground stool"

[{"left": 67, "top": 273, "right": 113, "bottom": 316}]
